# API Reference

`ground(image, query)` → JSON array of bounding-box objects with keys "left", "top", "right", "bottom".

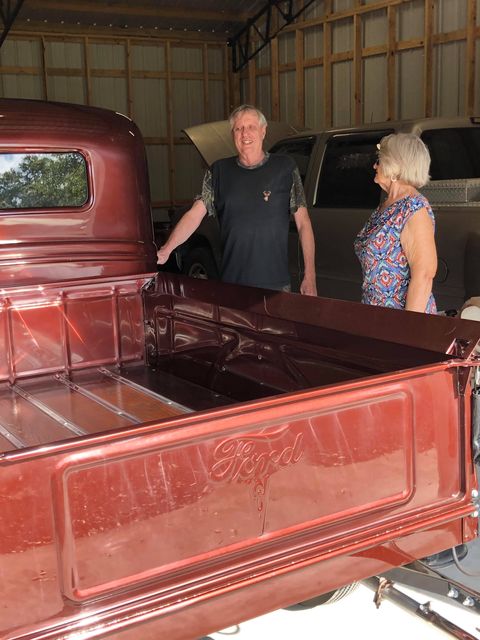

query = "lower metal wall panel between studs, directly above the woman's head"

[{"left": 395, "top": 49, "right": 424, "bottom": 119}]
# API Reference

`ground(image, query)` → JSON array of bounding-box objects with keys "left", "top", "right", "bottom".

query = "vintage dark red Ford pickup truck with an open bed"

[{"left": 0, "top": 100, "right": 480, "bottom": 640}]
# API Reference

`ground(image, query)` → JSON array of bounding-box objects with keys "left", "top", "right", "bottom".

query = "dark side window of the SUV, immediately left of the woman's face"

[{"left": 314, "top": 130, "right": 393, "bottom": 209}]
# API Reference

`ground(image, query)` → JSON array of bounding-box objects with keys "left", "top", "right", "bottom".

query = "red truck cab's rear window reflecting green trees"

[{"left": 0, "top": 152, "right": 88, "bottom": 209}]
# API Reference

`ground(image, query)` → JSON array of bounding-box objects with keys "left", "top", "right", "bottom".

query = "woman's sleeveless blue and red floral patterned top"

[{"left": 355, "top": 194, "right": 437, "bottom": 313}]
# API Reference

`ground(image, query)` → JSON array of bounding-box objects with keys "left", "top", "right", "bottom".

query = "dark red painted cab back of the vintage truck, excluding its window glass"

[{"left": 0, "top": 99, "right": 156, "bottom": 287}]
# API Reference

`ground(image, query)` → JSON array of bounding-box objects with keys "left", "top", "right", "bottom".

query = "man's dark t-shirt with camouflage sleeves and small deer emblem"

[{"left": 202, "top": 154, "right": 305, "bottom": 289}]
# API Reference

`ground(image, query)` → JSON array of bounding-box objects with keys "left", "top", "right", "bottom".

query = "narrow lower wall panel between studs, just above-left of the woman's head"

[{"left": 363, "top": 56, "right": 390, "bottom": 122}]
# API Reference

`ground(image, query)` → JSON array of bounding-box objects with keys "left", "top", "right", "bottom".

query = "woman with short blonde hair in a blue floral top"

[{"left": 355, "top": 133, "right": 437, "bottom": 313}]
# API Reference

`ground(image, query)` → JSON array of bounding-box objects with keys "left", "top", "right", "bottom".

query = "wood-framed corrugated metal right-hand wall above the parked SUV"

[{"left": 238, "top": 0, "right": 480, "bottom": 128}]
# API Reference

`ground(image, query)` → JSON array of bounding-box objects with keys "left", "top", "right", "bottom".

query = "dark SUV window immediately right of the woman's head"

[{"left": 421, "top": 127, "right": 480, "bottom": 180}]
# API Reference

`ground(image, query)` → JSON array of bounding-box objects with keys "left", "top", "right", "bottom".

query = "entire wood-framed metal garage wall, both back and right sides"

[{"left": 0, "top": 0, "right": 480, "bottom": 216}]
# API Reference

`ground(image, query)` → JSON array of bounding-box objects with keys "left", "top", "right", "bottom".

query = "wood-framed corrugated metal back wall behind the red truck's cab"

[{"left": 0, "top": 33, "right": 228, "bottom": 216}]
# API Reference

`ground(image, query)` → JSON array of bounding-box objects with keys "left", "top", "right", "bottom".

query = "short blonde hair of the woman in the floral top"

[{"left": 378, "top": 133, "right": 430, "bottom": 187}]
